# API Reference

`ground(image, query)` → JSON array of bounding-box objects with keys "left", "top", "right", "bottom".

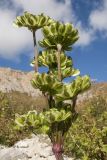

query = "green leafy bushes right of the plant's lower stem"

[{"left": 65, "top": 96, "right": 107, "bottom": 160}]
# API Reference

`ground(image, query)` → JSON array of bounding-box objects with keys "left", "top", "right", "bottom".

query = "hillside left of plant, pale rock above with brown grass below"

[{"left": 0, "top": 68, "right": 47, "bottom": 113}]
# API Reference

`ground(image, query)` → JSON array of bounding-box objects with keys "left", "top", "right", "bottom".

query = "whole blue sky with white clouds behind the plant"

[{"left": 0, "top": 0, "right": 107, "bottom": 82}]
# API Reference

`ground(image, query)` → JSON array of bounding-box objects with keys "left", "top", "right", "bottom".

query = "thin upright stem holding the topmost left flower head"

[{"left": 33, "top": 30, "right": 38, "bottom": 72}]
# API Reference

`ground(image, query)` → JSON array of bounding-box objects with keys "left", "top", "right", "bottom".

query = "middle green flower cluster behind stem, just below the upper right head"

[{"left": 31, "top": 49, "right": 80, "bottom": 79}]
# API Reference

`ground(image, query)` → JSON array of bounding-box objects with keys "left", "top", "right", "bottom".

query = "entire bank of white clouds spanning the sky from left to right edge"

[{"left": 0, "top": 0, "right": 107, "bottom": 59}]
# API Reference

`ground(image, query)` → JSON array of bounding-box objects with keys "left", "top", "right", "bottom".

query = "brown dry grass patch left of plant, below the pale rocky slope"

[{"left": 6, "top": 92, "right": 47, "bottom": 114}]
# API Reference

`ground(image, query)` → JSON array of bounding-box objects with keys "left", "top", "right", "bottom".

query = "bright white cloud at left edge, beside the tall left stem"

[{"left": 0, "top": 10, "right": 31, "bottom": 59}]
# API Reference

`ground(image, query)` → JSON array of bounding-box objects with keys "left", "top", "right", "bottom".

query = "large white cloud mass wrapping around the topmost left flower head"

[{"left": 0, "top": 0, "right": 73, "bottom": 59}]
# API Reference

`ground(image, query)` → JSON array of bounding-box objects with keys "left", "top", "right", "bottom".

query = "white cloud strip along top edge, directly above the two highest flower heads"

[{"left": 13, "top": 0, "right": 72, "bottom": 21}]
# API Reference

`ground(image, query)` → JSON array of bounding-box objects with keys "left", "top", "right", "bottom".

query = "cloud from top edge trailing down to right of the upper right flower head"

[{"left": 15, "top": 0, "right": 94, "bottom": 46}]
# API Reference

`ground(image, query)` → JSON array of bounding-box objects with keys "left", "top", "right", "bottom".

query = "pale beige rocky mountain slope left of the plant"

[{"left": 0, "top": 68, "right": 41, "bottom": 96}]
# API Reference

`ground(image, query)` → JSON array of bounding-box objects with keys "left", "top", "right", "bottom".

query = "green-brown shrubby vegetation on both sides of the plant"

[{"left": 0, "top": 92, "right": 107, "bottom": 160}]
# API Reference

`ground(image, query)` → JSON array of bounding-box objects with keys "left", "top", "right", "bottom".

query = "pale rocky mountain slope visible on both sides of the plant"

[{"left": 0, "top": 68, "right": 107, "bottom": 101}]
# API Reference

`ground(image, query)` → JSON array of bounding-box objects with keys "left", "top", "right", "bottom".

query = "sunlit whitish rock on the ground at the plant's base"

[{"left": 0, "top": 135, "right": 73, "bottom": 160}]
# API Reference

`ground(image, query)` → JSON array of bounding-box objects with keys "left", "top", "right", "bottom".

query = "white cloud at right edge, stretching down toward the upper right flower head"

[{"left": 76, "top": 0, "right": 107, "bottom": 46}]
